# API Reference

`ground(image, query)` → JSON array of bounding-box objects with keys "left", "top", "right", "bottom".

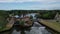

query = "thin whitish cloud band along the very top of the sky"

[{"left": 0, "top": 0, "right": 60, "bottom": 3}]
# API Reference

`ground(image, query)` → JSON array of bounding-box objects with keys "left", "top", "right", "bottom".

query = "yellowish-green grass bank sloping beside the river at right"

[{"left": 41, "top": 20, "right": 60, "bottom": 32}]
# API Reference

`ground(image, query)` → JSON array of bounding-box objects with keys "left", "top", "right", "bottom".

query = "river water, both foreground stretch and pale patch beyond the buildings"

[{"left": 0, "top": 13, "right": 51, "bottom": 34}]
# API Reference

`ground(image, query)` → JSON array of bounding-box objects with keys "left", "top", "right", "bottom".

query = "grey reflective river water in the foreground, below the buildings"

[{"left": 12, "top": 22, "right": 51, "bottom": 34}]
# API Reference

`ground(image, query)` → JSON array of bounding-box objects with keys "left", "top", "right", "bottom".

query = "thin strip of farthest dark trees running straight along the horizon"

[{"left": 0, "top": 10, "right": 60, "bottom": 13}]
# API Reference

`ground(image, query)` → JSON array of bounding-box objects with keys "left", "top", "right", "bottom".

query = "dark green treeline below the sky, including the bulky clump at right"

[{"left": 0, "top": 10, "right": 60, "bottom": 19}]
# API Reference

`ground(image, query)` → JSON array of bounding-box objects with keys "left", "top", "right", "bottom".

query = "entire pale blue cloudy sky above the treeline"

[{"left": 0, "top": 0, "right": 60, "bottom": 10}]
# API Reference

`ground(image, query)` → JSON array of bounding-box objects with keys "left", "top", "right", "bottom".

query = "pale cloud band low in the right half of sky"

[{"left": 25, "top": 4, "right": 60, "bottom": 10}]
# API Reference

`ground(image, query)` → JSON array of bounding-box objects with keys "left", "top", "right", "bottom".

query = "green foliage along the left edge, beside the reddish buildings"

[{"left": 0, "top": 11, "right": 8, "bottom": 30}]
